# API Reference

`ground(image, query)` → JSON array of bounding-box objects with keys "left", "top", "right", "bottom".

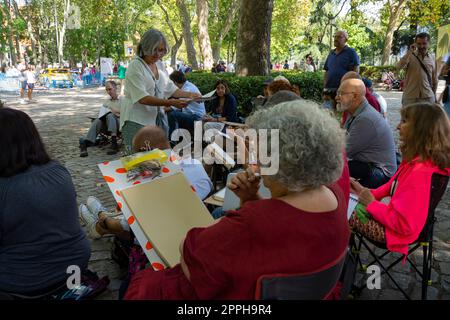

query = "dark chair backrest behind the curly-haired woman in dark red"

[{"left": 256, "top": 254, "right": 346, "bottom": 300}]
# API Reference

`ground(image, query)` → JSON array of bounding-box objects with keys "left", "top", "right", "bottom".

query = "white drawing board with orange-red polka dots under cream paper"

[{"left": 97, "top": 150, "right": 181, "bottom": 270}]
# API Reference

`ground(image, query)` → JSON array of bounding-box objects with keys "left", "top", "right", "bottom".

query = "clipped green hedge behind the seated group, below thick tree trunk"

[{"left": 187, "top": 71, "right": 323, "bottom": 116}]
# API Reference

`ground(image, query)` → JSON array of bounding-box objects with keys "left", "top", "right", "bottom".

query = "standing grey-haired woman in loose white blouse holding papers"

[{"left": 120, "top": 29, "right": 200, "bottom": 150}]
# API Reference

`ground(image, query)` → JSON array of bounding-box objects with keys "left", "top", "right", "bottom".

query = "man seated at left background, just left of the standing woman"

[{"left": 80, "top": 81, "right": 121, "bottom": 157}]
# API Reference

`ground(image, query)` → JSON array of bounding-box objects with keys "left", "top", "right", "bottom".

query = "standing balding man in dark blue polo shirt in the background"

[{"left": 323, "top": 30, "right": 359, "bottom": 92}]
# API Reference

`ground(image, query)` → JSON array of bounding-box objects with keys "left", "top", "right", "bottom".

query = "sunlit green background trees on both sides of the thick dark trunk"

[{"left": 0, "top": 0, "right": 450, "bottom": 67}]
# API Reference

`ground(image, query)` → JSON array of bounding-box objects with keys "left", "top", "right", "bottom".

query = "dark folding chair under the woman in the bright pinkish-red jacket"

[{"left": 350, "top": 173, "right": 449, "bottom": 300}]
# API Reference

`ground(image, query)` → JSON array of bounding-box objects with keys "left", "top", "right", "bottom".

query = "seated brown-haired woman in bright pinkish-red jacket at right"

[{"left": 350, "top": 102, "right": 450, "bottom": 258}]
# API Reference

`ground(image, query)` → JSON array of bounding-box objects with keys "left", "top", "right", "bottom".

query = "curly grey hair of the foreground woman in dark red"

[{"left": 247, "top": 100, "right": 345, "bottom": 191}]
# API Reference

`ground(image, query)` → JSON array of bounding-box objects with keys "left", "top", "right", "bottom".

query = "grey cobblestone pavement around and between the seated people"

[{"left": 2, "top": 88, "right": 450, "bottom": 299}]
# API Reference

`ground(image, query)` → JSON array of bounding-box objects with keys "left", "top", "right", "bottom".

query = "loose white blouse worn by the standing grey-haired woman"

[{"left": 120, "top": 57, "right": 178, "bottom": 128}]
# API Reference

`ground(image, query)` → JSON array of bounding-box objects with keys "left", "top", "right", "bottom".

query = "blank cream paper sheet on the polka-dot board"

[{"left": 121, "top": 173, "right": 214, "bottom": 267}]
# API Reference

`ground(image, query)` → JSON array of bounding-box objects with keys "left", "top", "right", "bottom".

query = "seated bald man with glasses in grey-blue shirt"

[{"left": 336, "top": 79, "right": 397, "bottom": 189}]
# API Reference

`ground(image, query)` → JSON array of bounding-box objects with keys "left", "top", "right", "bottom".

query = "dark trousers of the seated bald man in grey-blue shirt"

[{"left": 348, "top": 160, "right": 390, "bottom": 189}]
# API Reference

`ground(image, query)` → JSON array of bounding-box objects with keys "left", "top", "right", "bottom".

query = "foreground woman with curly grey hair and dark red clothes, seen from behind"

[{"left": 125, "top": 100, "right": 350, "bottom": 299}]
